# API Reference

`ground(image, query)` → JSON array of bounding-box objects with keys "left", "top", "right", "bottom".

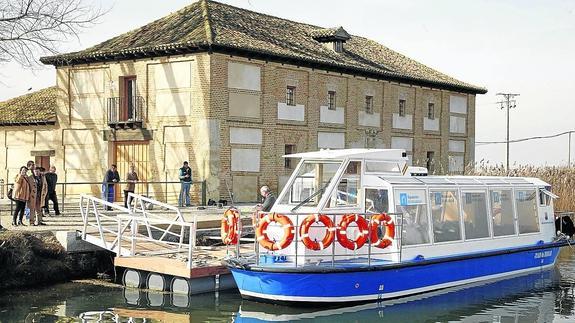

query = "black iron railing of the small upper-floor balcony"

[{"left": 108, "top": 96, "right": 146, "bottom": 129}]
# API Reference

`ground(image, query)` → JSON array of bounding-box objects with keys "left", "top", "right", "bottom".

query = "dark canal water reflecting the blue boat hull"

[{"left": 0, "top": 248, "right": 575, "bottom": 323}]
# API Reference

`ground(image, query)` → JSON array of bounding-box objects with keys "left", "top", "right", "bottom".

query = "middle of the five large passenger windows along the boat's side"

[{"left": 461, "top": 192, "right": 489, "bottom": 239}]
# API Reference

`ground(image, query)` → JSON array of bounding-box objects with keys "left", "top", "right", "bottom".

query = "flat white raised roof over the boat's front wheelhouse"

[{"left": 283, "top": 148, "right": 407, "bottom": 161}]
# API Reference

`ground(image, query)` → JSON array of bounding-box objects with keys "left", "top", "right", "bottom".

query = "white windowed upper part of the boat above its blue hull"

[{"left": 259, "top": 149, "right": 557, "bottom": 265}]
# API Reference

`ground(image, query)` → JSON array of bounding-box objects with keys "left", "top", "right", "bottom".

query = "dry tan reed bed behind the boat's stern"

[{"left": 465, "top": 162, "right": 575, "bottom": 212}]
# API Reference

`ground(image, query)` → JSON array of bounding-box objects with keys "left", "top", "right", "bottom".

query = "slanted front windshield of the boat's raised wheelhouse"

[{"left": 281, "top": 161, "right": 341, "bottom": 207}]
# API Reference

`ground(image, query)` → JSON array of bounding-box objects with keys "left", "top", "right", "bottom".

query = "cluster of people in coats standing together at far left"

[{"left": 12, "top": 161, "right": 60, "bottom": 226}]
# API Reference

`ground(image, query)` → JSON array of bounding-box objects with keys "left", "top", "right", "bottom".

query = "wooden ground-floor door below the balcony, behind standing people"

[{"left": 115, "top": 141, "right": 149, "bottom": 200}]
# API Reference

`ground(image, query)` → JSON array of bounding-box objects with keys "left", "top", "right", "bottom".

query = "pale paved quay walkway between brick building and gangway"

[{"left": 0, "top": 204, "right": 254, "bottom": 231}]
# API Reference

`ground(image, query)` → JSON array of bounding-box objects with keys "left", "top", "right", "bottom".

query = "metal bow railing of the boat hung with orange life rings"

[{"left": 235, "top": 212, "right": 403, "bottom": 267}]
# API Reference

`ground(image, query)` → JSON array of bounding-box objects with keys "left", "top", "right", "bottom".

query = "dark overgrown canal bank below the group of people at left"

[{"left": 0, "top": 231, "right": 114, "bottom": 290}]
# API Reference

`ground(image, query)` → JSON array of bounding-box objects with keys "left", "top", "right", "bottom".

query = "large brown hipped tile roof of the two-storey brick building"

[{"left": 41, "top": 0, "right": 487, "bottom": 93}]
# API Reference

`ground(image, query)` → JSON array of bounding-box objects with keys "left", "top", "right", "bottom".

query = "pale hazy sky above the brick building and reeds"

[{"left": 0, "top": 0, "right": 575, "bottom": 165}]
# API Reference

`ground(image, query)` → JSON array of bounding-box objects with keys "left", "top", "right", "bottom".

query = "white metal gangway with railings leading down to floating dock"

[{"left": 80, "top": 193, "right": 197, "bottom": 269}]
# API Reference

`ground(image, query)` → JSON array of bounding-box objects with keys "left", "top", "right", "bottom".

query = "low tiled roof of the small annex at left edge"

[{"left": 0, "top": 86, "right": 57, "bottom": 126}]
